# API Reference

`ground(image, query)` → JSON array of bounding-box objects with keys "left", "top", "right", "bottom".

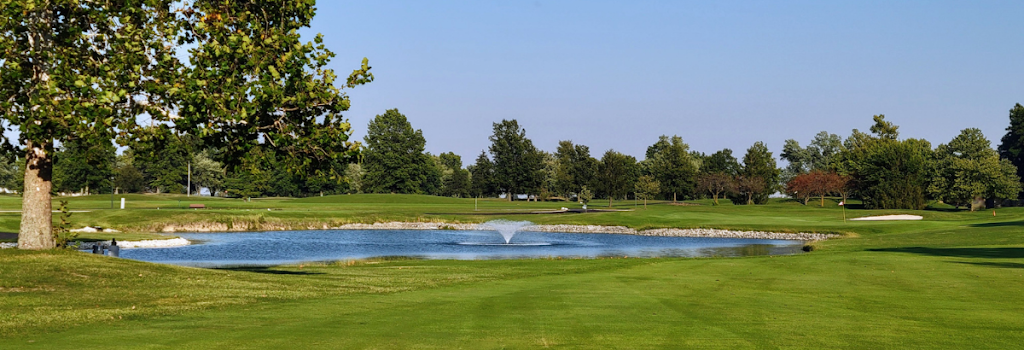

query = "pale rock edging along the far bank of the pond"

[{"left": 333, "top": 222, "right": 841, "bottom": 240}]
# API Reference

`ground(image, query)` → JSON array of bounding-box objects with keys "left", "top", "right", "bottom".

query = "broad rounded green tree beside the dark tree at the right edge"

[{"left": 928, "top": 128, "right": 1021, "bottom": 211}]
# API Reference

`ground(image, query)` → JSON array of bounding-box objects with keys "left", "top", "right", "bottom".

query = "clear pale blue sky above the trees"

[{"left": 303, "top": 0, "right": 1024, "bottom": 165}]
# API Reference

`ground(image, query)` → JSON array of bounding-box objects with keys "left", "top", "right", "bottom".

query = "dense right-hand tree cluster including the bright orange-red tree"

[{"left": 781, "top": 114, "right": 1024, "bottom": 209}]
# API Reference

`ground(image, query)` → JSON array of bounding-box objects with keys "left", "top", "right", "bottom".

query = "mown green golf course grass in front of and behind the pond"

[{"left": 0, "top": 192, "right": 1024, "bottom": 349}]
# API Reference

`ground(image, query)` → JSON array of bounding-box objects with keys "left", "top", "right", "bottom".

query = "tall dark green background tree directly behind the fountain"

[{"left": 489, "top": 119, "right": 544, "bottom": 201}]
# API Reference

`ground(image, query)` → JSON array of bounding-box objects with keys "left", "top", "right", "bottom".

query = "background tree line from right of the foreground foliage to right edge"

[{"left": 354, "top": 104, "right": 1024, "bottom": 209}]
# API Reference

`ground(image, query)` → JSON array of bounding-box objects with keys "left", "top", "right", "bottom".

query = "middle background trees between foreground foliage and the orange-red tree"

[{"left": 360, "top": 110, "right": 779, "bottom": 206}]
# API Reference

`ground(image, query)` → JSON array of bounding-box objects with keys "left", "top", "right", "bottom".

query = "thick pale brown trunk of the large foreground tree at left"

[{"left": 17, "top": 141, "right": 56, "bottom": 250}]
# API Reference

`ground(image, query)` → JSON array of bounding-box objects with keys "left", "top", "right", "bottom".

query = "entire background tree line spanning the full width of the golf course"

[{"left": 8, "top": 104, "right": 1024, "bottom": 214}]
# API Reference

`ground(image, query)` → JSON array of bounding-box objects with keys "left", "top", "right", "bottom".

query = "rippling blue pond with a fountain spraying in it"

[{"left": 121, "top": 230, "right": 803, "bottom": 267}]
